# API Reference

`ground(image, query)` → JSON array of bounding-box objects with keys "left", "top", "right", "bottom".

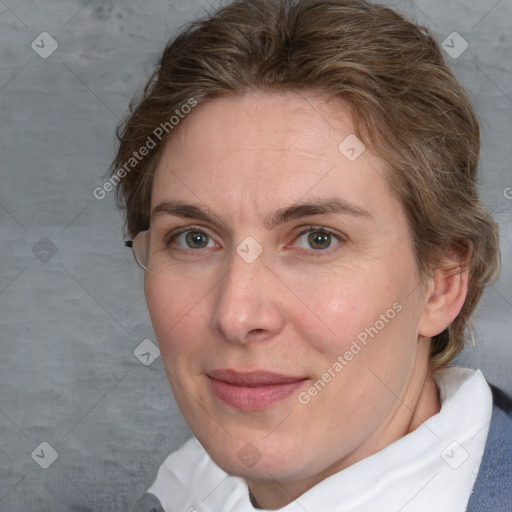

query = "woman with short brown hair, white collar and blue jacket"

[{"left": 112, "top": 0, "right": 512, "bottom": 512}]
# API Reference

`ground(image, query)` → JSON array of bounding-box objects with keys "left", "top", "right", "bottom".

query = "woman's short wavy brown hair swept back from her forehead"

[{"left": 111, "top": 0, "right": 500, "bottom": 369}]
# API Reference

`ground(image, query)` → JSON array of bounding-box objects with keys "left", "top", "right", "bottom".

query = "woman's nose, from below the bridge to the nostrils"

[{"left": 211, "top": 246, "right": 284, "bottom": 344}]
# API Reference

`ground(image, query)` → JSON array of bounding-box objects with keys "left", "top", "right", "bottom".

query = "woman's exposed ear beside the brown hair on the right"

[{"left": 418, "top": 247, "right": 471, "bottom": 338}]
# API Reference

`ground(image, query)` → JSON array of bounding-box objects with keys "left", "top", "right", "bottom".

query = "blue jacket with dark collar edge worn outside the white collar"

[{"left": 130, "top": 385, "right": 512, "bottom": 512}]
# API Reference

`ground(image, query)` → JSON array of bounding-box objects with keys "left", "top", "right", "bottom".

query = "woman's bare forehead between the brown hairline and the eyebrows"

[{"left": 151, "top": 92, "right": 390, "bottom": 224}]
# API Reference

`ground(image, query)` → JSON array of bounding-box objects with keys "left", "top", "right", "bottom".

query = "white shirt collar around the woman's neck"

[{"left": 148, "top": 367, "right": 492, "bottom": 512}]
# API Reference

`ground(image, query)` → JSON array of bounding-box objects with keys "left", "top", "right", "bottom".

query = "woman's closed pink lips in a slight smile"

[{"left": 207, "top": 369, "right": 309, "bottom": 411}]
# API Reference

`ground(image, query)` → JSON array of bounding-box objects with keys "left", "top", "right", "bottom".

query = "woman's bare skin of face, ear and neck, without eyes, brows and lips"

[{"left": 145, "top": 92, "right": 467, "bottom": 508}]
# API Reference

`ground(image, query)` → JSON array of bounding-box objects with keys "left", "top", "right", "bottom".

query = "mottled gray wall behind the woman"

[{"left": 0, "top": 0, "right": 512, "bottom": 512}]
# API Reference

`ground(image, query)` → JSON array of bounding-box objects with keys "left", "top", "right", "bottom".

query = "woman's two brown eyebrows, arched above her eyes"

[{"left": 151, "top": 197, "right": 373, "bottom": 231}]
